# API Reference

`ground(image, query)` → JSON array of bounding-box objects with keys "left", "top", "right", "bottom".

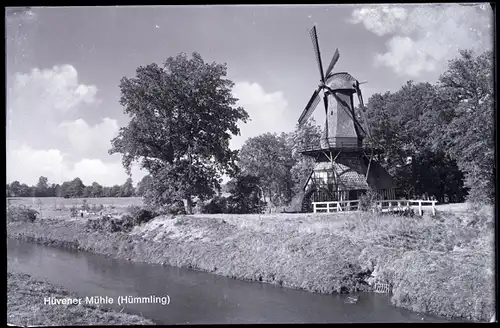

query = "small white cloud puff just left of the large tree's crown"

[{"left": 57, "top": 117, "right": 120, "bottom": 157}]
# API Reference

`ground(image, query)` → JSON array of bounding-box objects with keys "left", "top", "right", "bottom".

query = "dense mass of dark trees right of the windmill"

[{"left": 367, "top": 50, "right": 494, "bottom": 201}]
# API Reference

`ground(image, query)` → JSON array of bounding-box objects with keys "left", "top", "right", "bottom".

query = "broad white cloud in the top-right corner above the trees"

[{"left": 349, "top": 4, "right": 493, "bottom": 77}]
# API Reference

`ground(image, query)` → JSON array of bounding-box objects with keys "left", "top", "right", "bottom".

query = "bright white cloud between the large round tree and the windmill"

[{"left": 231, "top": 82, "right": 294, "bottom": 149}]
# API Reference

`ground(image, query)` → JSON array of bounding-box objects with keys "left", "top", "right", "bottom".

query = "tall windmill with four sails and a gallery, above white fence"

[{"left": 299, "top": 26, "right": 395, "bottom": 211}]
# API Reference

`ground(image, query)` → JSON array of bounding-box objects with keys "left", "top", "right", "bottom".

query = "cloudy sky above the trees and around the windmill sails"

[{"left": 6, "top": 3, "right": 494, "bottom": 186}]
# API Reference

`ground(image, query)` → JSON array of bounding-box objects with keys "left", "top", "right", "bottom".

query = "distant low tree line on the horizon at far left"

[{"left": 6, "top": 176, "right": 149, "bottom": 198}]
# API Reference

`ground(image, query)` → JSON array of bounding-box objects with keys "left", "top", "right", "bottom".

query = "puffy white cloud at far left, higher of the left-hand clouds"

[{"left": 9, "top": 65, "right": 97, "bottom": 114}]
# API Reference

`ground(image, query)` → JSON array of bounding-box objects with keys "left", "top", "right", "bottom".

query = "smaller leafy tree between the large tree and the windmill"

[{"left": 239, "top": 133, "right": 295, "bottom": 206}]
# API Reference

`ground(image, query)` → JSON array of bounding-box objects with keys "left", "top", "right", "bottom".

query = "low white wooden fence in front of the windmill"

[{"left": 312, "top": 199, "right": 437, "bottom": 215}]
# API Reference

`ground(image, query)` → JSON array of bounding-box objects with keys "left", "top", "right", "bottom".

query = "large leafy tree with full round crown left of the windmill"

[{"left": 110, "top": 53, "right": 248, "bottom": 213}]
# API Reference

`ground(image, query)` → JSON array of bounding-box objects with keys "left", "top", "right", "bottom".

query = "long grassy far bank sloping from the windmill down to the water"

[{"left": 7, "top": 205, "right": 494, "bottom": 321}]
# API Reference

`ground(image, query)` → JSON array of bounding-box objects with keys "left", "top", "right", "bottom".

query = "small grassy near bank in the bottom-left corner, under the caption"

[{"left": 7, "top": 272, "right": 154, "bottom": 326}]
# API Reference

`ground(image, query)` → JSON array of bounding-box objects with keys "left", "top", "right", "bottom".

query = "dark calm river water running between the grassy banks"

[{"left": 7, "top": 240, "right": 458, "bottom": 324}]
